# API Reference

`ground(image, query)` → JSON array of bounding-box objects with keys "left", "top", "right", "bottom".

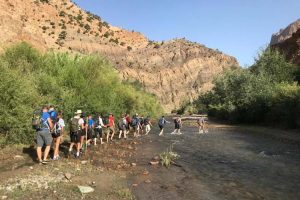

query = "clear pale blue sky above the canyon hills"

[{"left": 74, "top": 0, "right": 300, "bottom": 66}]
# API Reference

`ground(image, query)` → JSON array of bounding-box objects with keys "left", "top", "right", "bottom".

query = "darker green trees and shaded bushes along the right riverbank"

[{"left": 195, "top": 48, "right": 300, "bottom": 128}]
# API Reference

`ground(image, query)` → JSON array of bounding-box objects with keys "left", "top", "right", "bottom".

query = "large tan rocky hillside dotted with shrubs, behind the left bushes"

[{"left": 0, "top": 0, "right": 238, "bottom": 112}]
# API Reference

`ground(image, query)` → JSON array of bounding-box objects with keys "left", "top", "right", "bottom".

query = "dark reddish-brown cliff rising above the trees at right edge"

[{"left": 270, "top": 19, "right": 300, "bottom": 66}]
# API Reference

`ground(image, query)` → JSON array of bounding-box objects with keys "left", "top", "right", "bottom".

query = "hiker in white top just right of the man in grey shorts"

[{"left": 52, "top": 113, "right": 65, "bottom": 160}]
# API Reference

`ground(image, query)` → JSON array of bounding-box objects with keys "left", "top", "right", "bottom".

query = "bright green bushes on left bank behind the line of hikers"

[{"left": 0, "top": 43, "right": 161, "bottom": 144}]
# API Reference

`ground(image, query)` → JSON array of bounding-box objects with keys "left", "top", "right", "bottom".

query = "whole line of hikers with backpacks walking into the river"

[{"left": 32, "top": 106, "right": 205, "bottom": 164}]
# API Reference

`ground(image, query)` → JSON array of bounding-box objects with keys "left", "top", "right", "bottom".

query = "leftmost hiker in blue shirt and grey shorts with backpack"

[{"left": 36, "top": 106, "right": 53, "bottom": 164}]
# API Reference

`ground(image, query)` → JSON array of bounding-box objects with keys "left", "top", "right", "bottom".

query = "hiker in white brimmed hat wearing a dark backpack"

[{"left": 69, "top": 110, "right": 84, "bottom": 158}]
